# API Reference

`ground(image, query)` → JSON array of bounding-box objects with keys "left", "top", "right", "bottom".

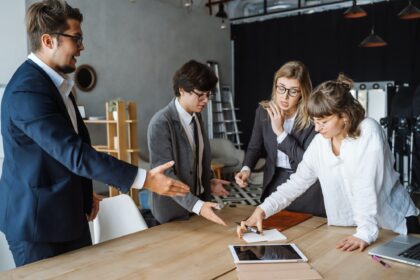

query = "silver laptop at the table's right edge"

[{"left": 368, "top": 235, "right": 420, "bottom": 266}]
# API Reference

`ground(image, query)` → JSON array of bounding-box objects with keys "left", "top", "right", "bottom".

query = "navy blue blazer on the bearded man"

[{"left": 0, "top": 60, "right": 137, "bottom": 242}]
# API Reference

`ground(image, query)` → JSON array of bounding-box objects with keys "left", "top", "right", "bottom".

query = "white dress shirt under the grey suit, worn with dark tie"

[{"left": 175, "top": 98, "right": 204, "bottom": 215}]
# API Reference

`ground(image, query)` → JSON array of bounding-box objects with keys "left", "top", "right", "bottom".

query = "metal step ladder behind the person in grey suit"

[{"left": 207, "top": 61, "right": 242, "bottom": 149}]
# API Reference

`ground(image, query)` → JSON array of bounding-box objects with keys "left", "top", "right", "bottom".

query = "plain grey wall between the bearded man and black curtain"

[{"left": 23, "top": 0, "right": 232, "bottom": 155}]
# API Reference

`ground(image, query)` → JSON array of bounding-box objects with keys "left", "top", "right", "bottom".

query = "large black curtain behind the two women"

[{"left": 231, "top": 0, "right": 420, "bottom": 148}]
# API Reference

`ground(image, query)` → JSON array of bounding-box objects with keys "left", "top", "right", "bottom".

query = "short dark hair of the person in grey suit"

[{"left": 173, "top": 60, "right": 218, "bottom": 96}]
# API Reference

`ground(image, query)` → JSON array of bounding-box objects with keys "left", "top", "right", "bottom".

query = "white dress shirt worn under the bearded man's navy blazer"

[{"left": 28, "top": 53, "right": 146, "bottom": 189}]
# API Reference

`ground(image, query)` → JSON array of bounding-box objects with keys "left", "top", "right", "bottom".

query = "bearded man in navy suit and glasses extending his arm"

[{"left": 0, "top": 0, "right": 189, "bottom": 266}]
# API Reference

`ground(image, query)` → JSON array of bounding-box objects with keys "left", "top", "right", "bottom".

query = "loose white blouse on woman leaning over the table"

[{"left": 259, "top": 118, "right": 419, "bottom": 244}]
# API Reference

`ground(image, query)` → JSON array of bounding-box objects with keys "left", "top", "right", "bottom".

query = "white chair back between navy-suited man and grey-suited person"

[{"left": 92, "top": 194, "right": 147, "bottom": 244}]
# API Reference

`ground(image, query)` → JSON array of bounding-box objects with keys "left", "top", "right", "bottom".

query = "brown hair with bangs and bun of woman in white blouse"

[{"left": 308, "top": 73, "right": 365, "bottom": 138}]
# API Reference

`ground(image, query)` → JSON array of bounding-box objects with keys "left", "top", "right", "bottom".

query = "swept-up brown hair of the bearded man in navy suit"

[{"left": 26, "top": 0, "right": 83, "bottom": 52}]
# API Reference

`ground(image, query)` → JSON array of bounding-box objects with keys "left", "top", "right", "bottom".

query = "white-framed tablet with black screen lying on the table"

[{"left": 229, "top": 243, "right": 308, "bottom": 263}]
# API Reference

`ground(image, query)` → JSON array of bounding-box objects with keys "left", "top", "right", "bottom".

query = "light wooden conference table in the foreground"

[{"left": 0, "top": 205, "right": 420, "bottom": 280}]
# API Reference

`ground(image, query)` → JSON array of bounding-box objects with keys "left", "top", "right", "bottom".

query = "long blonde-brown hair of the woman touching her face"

[{"left": 260, "top": 61, "right": 312, "bottom": 131}]
